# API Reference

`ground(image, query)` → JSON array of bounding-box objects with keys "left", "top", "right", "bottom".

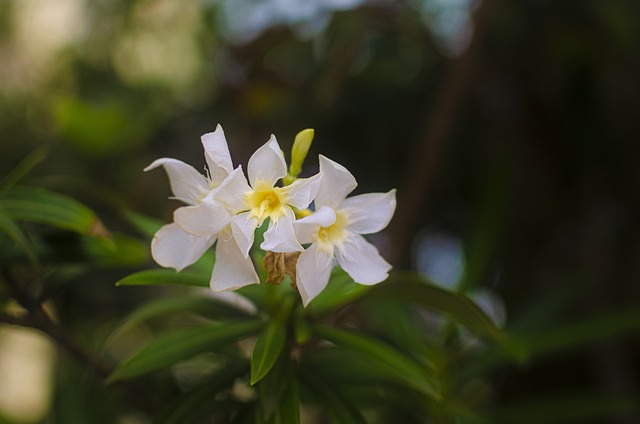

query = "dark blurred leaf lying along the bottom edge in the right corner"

[{"left": 486, "top": 393, "right": 640, "bottom": 424}]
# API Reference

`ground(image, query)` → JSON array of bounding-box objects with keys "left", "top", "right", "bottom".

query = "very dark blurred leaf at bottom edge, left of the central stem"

[{"left": 153, "top": 361, "right": 249, "bottom": 424}]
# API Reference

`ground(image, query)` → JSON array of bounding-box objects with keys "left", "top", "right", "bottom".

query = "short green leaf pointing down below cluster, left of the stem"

[{"left": 251, "top": 319, "right": 287, "bottom": 385}]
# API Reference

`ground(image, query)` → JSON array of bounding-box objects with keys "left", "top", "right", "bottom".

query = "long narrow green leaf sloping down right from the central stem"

[{"left": 313, "top": 325, "right": 442, "bottom": 400}]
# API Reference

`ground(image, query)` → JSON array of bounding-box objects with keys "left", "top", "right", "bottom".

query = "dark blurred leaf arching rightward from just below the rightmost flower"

[{"left": 368, "top": 273, "right": 504, "bottom": 340}]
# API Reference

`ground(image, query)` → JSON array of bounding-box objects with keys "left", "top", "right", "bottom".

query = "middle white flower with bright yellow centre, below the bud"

[{"left": 216, "top": 135, "right": 321, "bottom": 257}]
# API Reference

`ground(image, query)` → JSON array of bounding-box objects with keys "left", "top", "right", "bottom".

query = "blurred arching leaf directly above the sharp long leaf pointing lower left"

[{"left": 109, "top": 296, "right": 252, "bottom": 340}]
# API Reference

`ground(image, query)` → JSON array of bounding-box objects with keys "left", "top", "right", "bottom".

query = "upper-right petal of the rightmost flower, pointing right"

[{"left": 340, "top": 189, "right": 396, "bottom": 234}]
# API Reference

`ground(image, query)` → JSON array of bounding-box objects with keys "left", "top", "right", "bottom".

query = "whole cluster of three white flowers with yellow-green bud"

[{"left": 145, "top": 125, "right": 396, "bottom": 306}]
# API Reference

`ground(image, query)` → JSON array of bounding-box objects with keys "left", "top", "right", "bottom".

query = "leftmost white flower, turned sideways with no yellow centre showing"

[{"left": 145, "top": 125, "right": 259, "bottom": 291}]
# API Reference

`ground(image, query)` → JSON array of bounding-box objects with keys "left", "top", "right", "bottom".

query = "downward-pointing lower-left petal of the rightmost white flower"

[{"left": 296, "top": 243, "right": 333, "bottom": 307}]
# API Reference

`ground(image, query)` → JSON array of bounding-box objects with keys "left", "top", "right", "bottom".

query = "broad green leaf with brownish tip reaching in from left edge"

[{"left": 0, "top": 186, "right": 108, "bottom": 237}]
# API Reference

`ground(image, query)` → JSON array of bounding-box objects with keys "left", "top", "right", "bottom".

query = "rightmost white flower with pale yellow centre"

[{"left": 295, "top": 155, "right": 396, "bottom": 306}]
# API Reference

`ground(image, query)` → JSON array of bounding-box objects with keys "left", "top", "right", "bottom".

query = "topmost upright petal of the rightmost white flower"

[{"left": 315, "top": 155, "right": 358, "bottom": 209}]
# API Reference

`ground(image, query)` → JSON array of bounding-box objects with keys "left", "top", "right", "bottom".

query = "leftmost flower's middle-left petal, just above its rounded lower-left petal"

[{"left": 173, "top": 199, "right": 231, "bottom": 237}]
